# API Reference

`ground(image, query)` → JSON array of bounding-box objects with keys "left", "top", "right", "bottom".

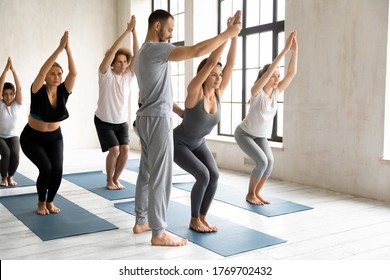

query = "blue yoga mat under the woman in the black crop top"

[{"left": 0, "top": 193, "right": 117, "bottom": 241}]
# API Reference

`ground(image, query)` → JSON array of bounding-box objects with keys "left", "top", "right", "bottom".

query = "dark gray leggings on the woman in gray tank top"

[{"left": 174, "top": 139, "right": 219, "bottom": 218}]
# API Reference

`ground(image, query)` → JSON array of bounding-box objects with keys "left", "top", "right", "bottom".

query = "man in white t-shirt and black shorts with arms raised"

[{"left": 94, "top": 16, "right": 139, "bottom": 190}]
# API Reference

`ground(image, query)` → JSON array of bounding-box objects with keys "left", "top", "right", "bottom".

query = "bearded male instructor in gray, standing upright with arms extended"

[{"left": 133, "top": 10, "right": 241, "bottom": 246}]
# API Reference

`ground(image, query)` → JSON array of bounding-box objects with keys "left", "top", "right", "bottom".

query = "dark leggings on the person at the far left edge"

[{"left": 0, "top": 136, "right": 20, "bottom": 178}]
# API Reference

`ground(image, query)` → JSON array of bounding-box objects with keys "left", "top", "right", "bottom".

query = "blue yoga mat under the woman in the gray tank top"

[{"left": 114, "top": 201, "right": 286, "bottom": 257}]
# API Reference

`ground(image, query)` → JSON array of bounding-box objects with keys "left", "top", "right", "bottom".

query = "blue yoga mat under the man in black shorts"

[{"left": 63, "top": 171, "right": 135, "bottom": 200}]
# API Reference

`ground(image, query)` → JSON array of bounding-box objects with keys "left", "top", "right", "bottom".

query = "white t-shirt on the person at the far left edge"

[{"left": 0, "top": 100, "right": 22, "bottom": 138}]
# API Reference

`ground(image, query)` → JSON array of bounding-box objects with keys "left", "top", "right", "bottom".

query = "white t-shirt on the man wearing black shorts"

[{"left": 95, "top": 69, "right": 133, "bottom": 124}]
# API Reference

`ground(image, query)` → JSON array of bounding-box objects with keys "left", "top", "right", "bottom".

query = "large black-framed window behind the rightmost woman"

[{"left": 218, "top": 0, "right": 285, "bottom": 142}]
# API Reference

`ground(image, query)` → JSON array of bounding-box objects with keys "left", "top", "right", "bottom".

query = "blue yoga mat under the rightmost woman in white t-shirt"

[{"left": 173, "top": 182, "right": 313, "bottom": 217}]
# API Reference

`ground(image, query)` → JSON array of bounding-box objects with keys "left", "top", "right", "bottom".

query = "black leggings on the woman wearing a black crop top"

[{"left": 20, "top": 125, "right": 64, "bottom": 202}]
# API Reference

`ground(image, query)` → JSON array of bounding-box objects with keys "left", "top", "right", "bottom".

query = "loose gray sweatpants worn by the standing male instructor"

[{"left": 135, "top": 116, "right": 173, "bottom": 235}]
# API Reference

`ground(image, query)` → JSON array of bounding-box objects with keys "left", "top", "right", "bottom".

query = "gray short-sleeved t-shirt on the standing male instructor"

[{"left": 134, "top": 42, "right": 174, "bottom": 117}]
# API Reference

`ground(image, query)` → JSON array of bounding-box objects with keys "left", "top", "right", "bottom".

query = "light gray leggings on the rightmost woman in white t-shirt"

[{"left": 234, "top": 126, "right": 274, "bottom": 178}]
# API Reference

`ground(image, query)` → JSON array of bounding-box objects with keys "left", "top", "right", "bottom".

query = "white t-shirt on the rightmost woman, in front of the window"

[{"left": 240, "top": 88, "right": 279, "bottom": 137}]
